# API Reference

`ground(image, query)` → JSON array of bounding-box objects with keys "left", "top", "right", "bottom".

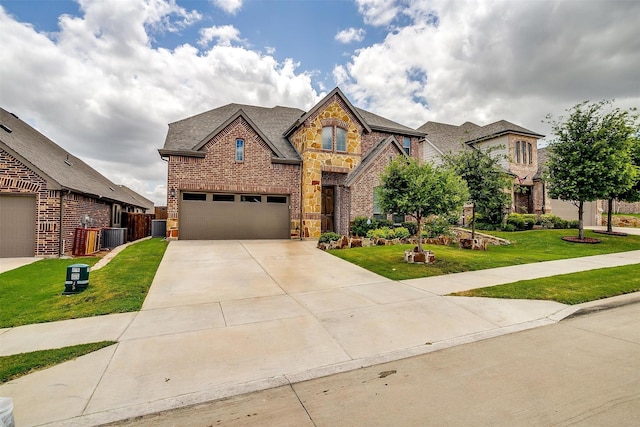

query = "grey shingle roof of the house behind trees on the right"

[{"left": 418, "top": 120, "right": 544, "bottom": 153}]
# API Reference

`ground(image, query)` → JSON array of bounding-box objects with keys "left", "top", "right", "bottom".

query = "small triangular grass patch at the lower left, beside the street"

[{"left": 0, "top": 341, "right": 115, "bottom": 384}]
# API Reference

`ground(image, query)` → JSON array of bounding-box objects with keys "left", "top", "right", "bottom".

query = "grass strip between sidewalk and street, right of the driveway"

[{"left": 452, "top": 264, "right": 640, "bottom": 305}]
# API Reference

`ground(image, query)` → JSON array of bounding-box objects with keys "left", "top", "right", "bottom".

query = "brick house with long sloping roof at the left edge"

[{"left": 0, "top": 108, "right": 153, "bottom": 257}]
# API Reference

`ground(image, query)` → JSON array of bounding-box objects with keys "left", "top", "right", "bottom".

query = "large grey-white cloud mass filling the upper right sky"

[{"left": 334, "top": 0, "right": 640, "bottom": 134}]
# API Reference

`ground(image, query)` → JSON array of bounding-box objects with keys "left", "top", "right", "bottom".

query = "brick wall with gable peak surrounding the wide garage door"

[{"left": 167, "top": 117, "right": 300, "bottom": 233}]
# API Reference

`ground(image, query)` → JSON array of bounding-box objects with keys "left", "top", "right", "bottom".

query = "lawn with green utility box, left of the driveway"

[{"left": 0, "top": 238, "right": 167, "bottom": 328}]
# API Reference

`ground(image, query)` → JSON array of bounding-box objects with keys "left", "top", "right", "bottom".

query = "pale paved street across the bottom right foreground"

[{"left": 110, "top": 303, "right": 640, "bottom": 427}]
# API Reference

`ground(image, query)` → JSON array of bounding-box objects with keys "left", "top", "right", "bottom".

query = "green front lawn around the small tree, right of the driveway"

[{"left": 329, "top": 230, "right": 640, "bottom": 280}]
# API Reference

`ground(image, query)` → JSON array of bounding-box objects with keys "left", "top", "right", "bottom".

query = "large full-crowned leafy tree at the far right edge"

[{"left": 546, "top": 101, "right": 637, "bottom": 240}]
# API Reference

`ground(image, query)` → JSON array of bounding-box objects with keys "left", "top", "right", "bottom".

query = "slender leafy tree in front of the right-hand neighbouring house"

[{"left": 444, "top": 147, "right": 513, "bottom": 239}]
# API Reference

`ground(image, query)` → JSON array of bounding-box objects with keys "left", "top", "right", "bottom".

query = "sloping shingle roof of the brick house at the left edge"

[{"left": 0, "top": 108, "right": 153, "bottom": 209}]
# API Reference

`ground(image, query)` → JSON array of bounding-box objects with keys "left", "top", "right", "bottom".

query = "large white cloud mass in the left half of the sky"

[{"left": 0, "top": 0, "right": 319, "bottom": 204}]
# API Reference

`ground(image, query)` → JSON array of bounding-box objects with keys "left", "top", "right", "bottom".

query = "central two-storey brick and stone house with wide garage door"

[{"left": 158, "top": 88, "right": 424, "bottom": 239}]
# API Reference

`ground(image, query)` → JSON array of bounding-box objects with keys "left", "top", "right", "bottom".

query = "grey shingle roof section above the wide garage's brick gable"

[{"left": 158, "top": 104, "right": 304, "bottom": 161}]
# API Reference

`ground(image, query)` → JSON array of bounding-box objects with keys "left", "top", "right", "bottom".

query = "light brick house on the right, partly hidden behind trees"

[{"left": 418, "top": 120, "right": 551, "bottom": 214}]
